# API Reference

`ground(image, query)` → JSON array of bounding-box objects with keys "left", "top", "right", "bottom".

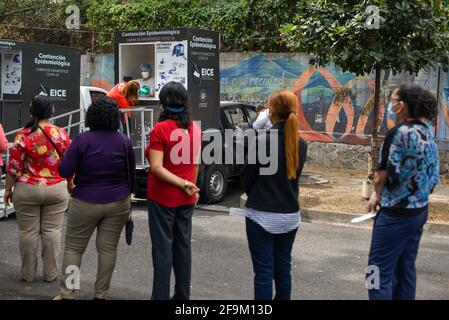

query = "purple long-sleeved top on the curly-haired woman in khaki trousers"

[{"left": 58, "top": 130, "right": 136, "bottom": 203}]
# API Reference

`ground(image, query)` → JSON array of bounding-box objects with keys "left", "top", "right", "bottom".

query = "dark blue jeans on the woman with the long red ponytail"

[{"left": 246, "top": 218, "right": 298, "bottom": 300}]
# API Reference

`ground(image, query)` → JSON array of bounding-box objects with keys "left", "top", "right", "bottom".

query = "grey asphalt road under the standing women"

[{"left": 0, "top": 203, "right": 449, "bottom": 299}]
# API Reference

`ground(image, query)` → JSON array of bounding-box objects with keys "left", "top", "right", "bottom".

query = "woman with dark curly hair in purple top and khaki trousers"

[{"left": 53, "top": 97, "right": 135, "bottom": 300}]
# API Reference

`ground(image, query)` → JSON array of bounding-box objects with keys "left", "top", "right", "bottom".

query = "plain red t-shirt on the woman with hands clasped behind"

[{"left": 145, "top": 120, "right": 201, "bottom": 208}]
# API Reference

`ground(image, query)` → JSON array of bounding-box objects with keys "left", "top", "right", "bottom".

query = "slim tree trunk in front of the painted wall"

[{"left": 368, "top": 64, "right": 382, "bottom": 181}]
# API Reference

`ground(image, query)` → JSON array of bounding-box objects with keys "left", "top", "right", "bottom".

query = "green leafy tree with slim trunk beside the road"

[{"left": 280, "top": 0, "right": 449, "bottom": 180}]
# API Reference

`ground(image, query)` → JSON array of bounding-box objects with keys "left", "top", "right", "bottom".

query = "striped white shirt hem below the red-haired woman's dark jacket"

[{"left": 246, "top": 208, "right": 301, "bottom": 234}]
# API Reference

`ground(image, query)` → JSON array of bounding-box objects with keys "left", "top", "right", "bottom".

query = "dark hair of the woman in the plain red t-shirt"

[{"left": 159, "top": 81, "right": 192, "bottom": 129}]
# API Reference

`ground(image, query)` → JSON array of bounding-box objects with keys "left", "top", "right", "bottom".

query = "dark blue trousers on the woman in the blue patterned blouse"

[{"left": 367, "top": 208, "right": 428, "bottom": 300}]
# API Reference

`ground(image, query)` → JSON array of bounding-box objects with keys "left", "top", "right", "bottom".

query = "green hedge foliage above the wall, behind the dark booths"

[{"left": 0, "top": 0, "right": 297, "bottom": 52}]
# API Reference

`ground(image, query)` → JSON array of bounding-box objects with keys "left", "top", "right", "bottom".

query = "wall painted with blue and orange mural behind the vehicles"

[{"left": 81, "top": 53, "right": 449, "bottom": 147}]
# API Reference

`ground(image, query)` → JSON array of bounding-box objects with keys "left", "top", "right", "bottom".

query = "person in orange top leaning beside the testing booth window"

[{"left": 108, "top": 80, "right": 140, "bottom": 131}]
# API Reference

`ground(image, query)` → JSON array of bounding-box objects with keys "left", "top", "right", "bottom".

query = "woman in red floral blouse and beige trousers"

[{"left": 4, "top": 96, "right": 70, "bottom": 282}]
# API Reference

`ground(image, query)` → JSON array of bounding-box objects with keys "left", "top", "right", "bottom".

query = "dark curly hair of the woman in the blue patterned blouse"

[{"left": 396, "top": 84, "right": 438, "bottom": 121}]
